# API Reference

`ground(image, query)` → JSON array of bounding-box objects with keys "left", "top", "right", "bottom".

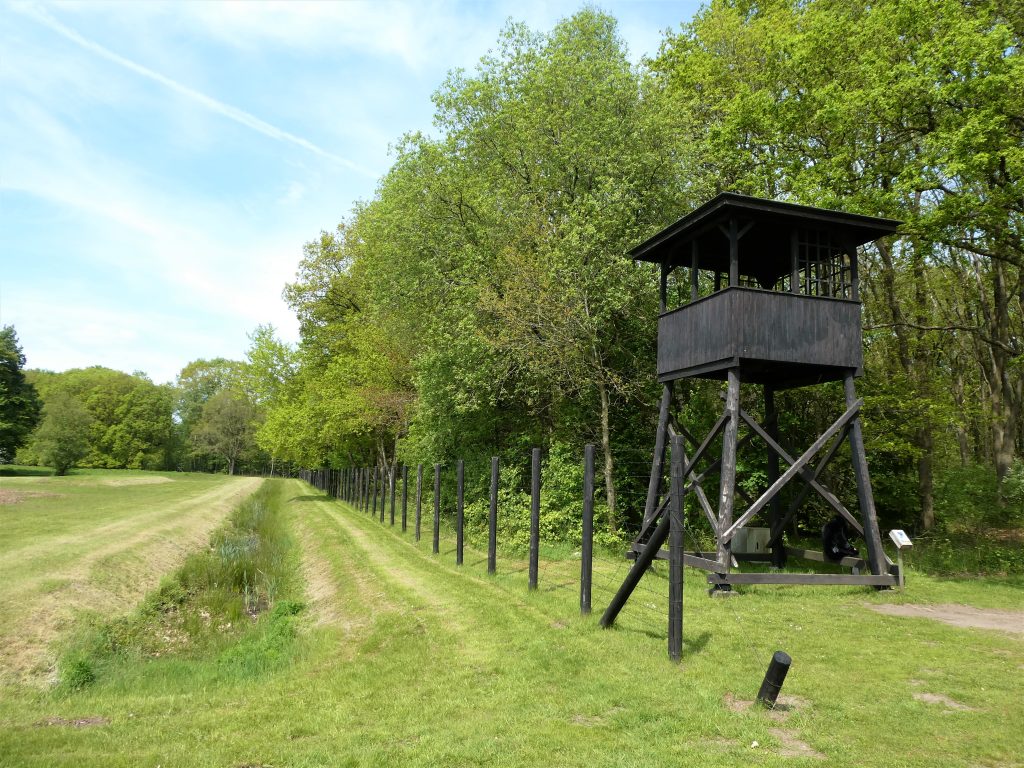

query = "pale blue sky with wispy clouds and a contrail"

[{"left": 0, "top": 0, "right": 698, "bottom": 383}]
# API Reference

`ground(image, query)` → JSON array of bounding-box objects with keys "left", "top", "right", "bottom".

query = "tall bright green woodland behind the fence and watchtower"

[{"left": 4, "top": 0, "right": 1024, "bottom": 535}]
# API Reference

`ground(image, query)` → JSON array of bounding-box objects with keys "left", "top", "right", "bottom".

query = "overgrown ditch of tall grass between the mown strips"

[{"left": 58, "top": 481, "right": 302, "bottom": 690}]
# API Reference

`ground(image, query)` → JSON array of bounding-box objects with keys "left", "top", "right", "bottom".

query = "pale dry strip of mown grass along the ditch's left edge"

[{"left": 0, "top": 478, "right": 261, "bottom": 683}]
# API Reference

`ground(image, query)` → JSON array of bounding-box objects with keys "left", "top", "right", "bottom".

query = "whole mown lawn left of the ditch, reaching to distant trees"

[{"left": 0, "top": 468, "right": 259, "bottom": 685}]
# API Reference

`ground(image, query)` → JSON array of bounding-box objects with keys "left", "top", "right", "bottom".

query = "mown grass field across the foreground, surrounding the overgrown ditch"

[{"left": 0, "top": 475, "right": 1024, "bottom": 768}]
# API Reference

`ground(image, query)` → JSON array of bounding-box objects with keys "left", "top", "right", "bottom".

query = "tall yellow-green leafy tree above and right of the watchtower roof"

[{"left": 652, "top": 0, "right": 1024, "bottom": 528}]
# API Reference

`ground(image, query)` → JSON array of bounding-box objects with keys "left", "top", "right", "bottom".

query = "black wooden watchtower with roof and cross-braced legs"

[{"left": 601, "top": 193, "right": 901, "bottom": 638}]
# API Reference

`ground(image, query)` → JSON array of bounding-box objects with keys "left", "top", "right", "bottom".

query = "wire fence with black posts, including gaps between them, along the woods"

[{"left": 298, "top": 445, "right": 699, "bottom": 651}]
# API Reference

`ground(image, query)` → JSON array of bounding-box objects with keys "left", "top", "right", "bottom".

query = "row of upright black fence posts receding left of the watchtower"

[{"left": 299, "top": 443, "right": 594, "bottom": 613}]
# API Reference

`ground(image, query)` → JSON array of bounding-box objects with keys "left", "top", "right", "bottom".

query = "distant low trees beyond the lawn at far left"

[{"left": 0, "top": 326, "right": 272, "bottom": 474}]
